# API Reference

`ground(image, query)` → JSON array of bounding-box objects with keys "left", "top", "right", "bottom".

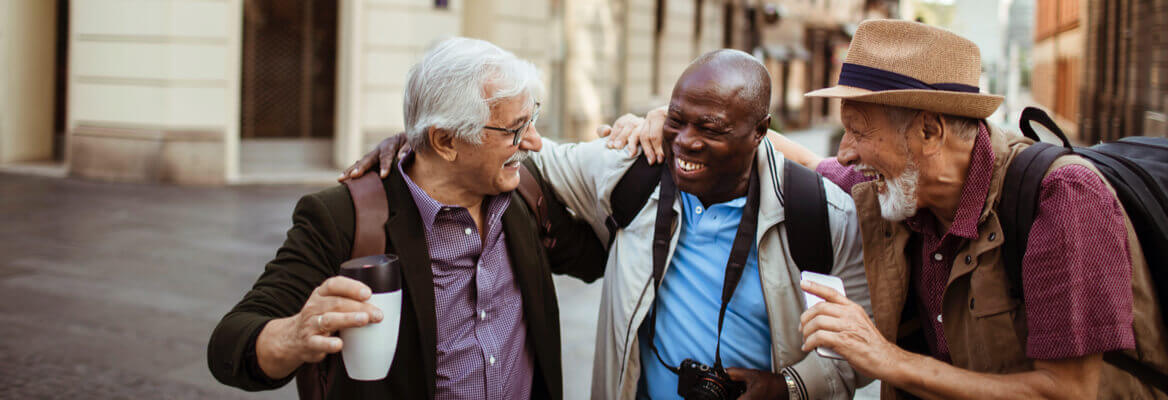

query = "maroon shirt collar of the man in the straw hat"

[{"left": 905, "top": 122, "right": 994, "bottom": 240}]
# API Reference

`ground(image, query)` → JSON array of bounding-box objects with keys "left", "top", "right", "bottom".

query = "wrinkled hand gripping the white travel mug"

[{"left": 256, "top": 276, "right": 383, "bottom": 378}]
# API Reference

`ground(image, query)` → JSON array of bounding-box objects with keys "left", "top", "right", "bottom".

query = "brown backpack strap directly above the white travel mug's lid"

[{"left": 345, "top": 173, "right": 389, "bottom": 258}]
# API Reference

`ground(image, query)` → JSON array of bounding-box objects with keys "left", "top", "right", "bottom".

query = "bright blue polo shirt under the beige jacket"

[{"left": 638, "top": 192, "right": 771, "bottom": 399}]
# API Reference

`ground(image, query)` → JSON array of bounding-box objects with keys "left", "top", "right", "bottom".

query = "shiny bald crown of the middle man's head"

[{"left": 674, "top": 49, "right": 771, "bottom": 120}]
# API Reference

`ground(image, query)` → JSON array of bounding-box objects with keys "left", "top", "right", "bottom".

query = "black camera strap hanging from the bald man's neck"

[{"left": 648, "top": 161, "right": 759, "bottom": 373}]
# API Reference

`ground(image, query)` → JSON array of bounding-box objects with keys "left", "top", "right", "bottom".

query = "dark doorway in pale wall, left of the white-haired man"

[{"left": 239, "top": 0, "right": 338, "bottom": 174}]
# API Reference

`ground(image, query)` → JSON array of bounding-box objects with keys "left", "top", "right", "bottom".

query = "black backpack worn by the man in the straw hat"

[{"left": 999, "top": 108, "right": 1168, "bottom": 393}]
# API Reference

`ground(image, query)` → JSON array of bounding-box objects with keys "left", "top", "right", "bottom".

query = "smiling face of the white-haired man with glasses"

[{"left": 453, "top": 96, "right": 540, "bottom": 195}]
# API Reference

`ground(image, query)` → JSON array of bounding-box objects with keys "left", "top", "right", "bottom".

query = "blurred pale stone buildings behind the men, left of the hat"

[{"left": 0, "top": 0, "right": 898, "bottom": 185}]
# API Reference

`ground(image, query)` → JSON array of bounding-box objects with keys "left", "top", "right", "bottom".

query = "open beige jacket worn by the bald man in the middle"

[{"left": 534, "top": 139, "right": 870, "bottom": 399}]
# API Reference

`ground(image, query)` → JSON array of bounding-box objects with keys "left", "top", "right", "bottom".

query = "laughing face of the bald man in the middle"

[{"left": 665, "top": 65, "right": 770, "bottom": 206}]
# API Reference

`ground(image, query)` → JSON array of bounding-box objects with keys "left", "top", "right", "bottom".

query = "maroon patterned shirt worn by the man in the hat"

[{"left": 816, "top": 125, "right": 1135, "bottom": 361}]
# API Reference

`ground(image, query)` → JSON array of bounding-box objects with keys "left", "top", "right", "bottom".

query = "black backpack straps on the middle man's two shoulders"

[{"left": 605, "top": 144, "right": 835, "bottom": 274}]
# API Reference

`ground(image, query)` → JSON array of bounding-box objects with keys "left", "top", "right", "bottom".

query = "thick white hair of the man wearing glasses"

[{"left": 402, "top": 37, "right": 543, "bottom": 150}]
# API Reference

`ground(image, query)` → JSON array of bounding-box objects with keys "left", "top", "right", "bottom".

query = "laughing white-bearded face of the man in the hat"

[{"left": 839, "top": 102, "right": 920, "bottom": 221}]
